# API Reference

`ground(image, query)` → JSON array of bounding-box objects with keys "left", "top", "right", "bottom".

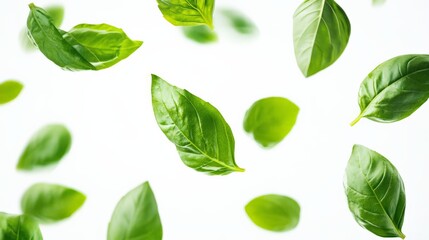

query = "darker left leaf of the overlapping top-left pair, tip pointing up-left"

[{"left": 27, "top": 3, "right": 95, "bottom": 70}]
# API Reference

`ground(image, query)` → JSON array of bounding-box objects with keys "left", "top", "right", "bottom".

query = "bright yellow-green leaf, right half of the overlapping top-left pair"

[{"left": 63, "top": 24, "right": 143, "bottom": 70}]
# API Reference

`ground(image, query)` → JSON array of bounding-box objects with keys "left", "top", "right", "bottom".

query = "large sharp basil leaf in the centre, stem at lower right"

[{"left": 152, "top": 75, "right": 244, "bottom": 175}]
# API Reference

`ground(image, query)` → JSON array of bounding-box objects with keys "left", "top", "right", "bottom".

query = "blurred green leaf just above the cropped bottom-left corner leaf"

[{"left": 21, "top": 183, "right": 86, "bottom": 223}]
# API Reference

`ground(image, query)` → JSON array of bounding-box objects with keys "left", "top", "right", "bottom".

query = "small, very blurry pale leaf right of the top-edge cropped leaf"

[{"left": 221, "top": 9, "right": 257, "bottom": 35}]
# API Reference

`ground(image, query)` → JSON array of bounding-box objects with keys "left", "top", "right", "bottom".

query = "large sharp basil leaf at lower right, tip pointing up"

[{"left": 344, "top": 145, "right": 405, "bottom": 238}]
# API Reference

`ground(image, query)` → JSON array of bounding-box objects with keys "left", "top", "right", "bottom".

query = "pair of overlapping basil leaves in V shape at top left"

[{"left": 27, "top": 4, "right": 142, "bottom": 70}]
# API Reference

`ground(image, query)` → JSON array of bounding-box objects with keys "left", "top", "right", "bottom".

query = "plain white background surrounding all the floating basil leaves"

[{"left": 0, "top": 0, "right": 429, "bottom": 240}]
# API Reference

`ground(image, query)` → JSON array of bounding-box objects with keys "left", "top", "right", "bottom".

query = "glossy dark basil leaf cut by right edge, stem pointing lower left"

[{"left": 350, "top": 55, "right": 429, "bottom": 126}]
